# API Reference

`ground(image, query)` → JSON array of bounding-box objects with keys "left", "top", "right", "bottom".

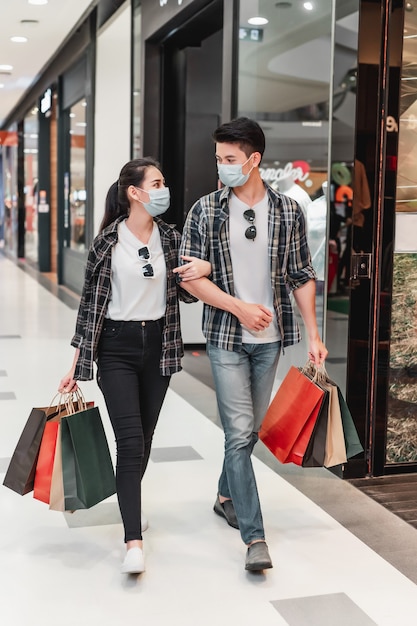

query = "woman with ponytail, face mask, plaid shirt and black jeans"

[{"left": 59, "top": 158, "right": 211, "bottom": 574}]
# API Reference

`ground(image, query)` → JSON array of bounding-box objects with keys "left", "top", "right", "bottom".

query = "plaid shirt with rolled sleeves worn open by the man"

[{"left": 180, "top": 183, "right": 316, "bottom": 351}]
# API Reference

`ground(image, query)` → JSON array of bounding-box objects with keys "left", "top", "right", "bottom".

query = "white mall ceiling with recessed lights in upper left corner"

[{"left": 0, "top": 0, "right": 97, "bottom": 127}]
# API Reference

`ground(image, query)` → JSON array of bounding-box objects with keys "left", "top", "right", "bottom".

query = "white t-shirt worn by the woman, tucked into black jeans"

[{"left": 106, "top": 220, "right": 166, "bottom": 321}]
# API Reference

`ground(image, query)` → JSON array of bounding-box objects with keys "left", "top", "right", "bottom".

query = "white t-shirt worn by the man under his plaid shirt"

[{"left": 229, "top": 192, "right": 280, "bottom": 343}]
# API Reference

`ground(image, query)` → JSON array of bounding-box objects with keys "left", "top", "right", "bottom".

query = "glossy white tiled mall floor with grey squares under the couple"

[{"left": 0, "top": 255, "right": 417, "bottom": 626}]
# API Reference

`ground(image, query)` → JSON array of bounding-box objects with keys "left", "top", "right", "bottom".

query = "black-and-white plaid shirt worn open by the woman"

[{"left": 71, "top": 215, "right": 196, "bottom": 380}]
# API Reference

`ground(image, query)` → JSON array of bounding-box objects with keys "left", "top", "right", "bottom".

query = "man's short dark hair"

[{"left": 212, "top": 117, "right": 265, "bottom": 158}]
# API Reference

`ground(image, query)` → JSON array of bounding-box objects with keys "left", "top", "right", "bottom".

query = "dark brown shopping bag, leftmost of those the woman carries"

[{"left": 3, "top": 396, "right": 65, "bottom": 496}]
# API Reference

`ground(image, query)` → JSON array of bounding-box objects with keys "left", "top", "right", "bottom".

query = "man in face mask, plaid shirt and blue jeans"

[{"left": 175, "top": 118, "right": 327, "bottom": 571}]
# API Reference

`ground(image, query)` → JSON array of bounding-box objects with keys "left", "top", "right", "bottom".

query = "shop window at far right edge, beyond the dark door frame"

[{"left": 381, "top": 7, "right": 417, "bottom": 463}]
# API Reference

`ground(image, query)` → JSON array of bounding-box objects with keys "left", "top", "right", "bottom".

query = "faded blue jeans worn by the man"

[{"left": 207, "top": 341, "right": 281, "bottom": 544}]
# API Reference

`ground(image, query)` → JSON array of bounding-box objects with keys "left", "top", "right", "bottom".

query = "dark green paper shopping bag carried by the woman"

[{"left": 61, "top": 407, "right": 116, "bottom": 511}]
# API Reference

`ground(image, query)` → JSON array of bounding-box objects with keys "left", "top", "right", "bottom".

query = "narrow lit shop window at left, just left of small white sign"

[{"left": 23, "top": 107, "right": 38, "bottom": 263}]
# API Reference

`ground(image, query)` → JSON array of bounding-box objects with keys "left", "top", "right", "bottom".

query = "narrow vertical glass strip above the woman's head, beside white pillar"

[{"left": 132, "top": 0, "right": 142, "bottom": 159}]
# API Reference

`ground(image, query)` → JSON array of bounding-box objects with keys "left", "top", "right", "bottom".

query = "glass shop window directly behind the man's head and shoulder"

[{"left": 238, "top": 0, "right": 333, "bottom": 334}]
